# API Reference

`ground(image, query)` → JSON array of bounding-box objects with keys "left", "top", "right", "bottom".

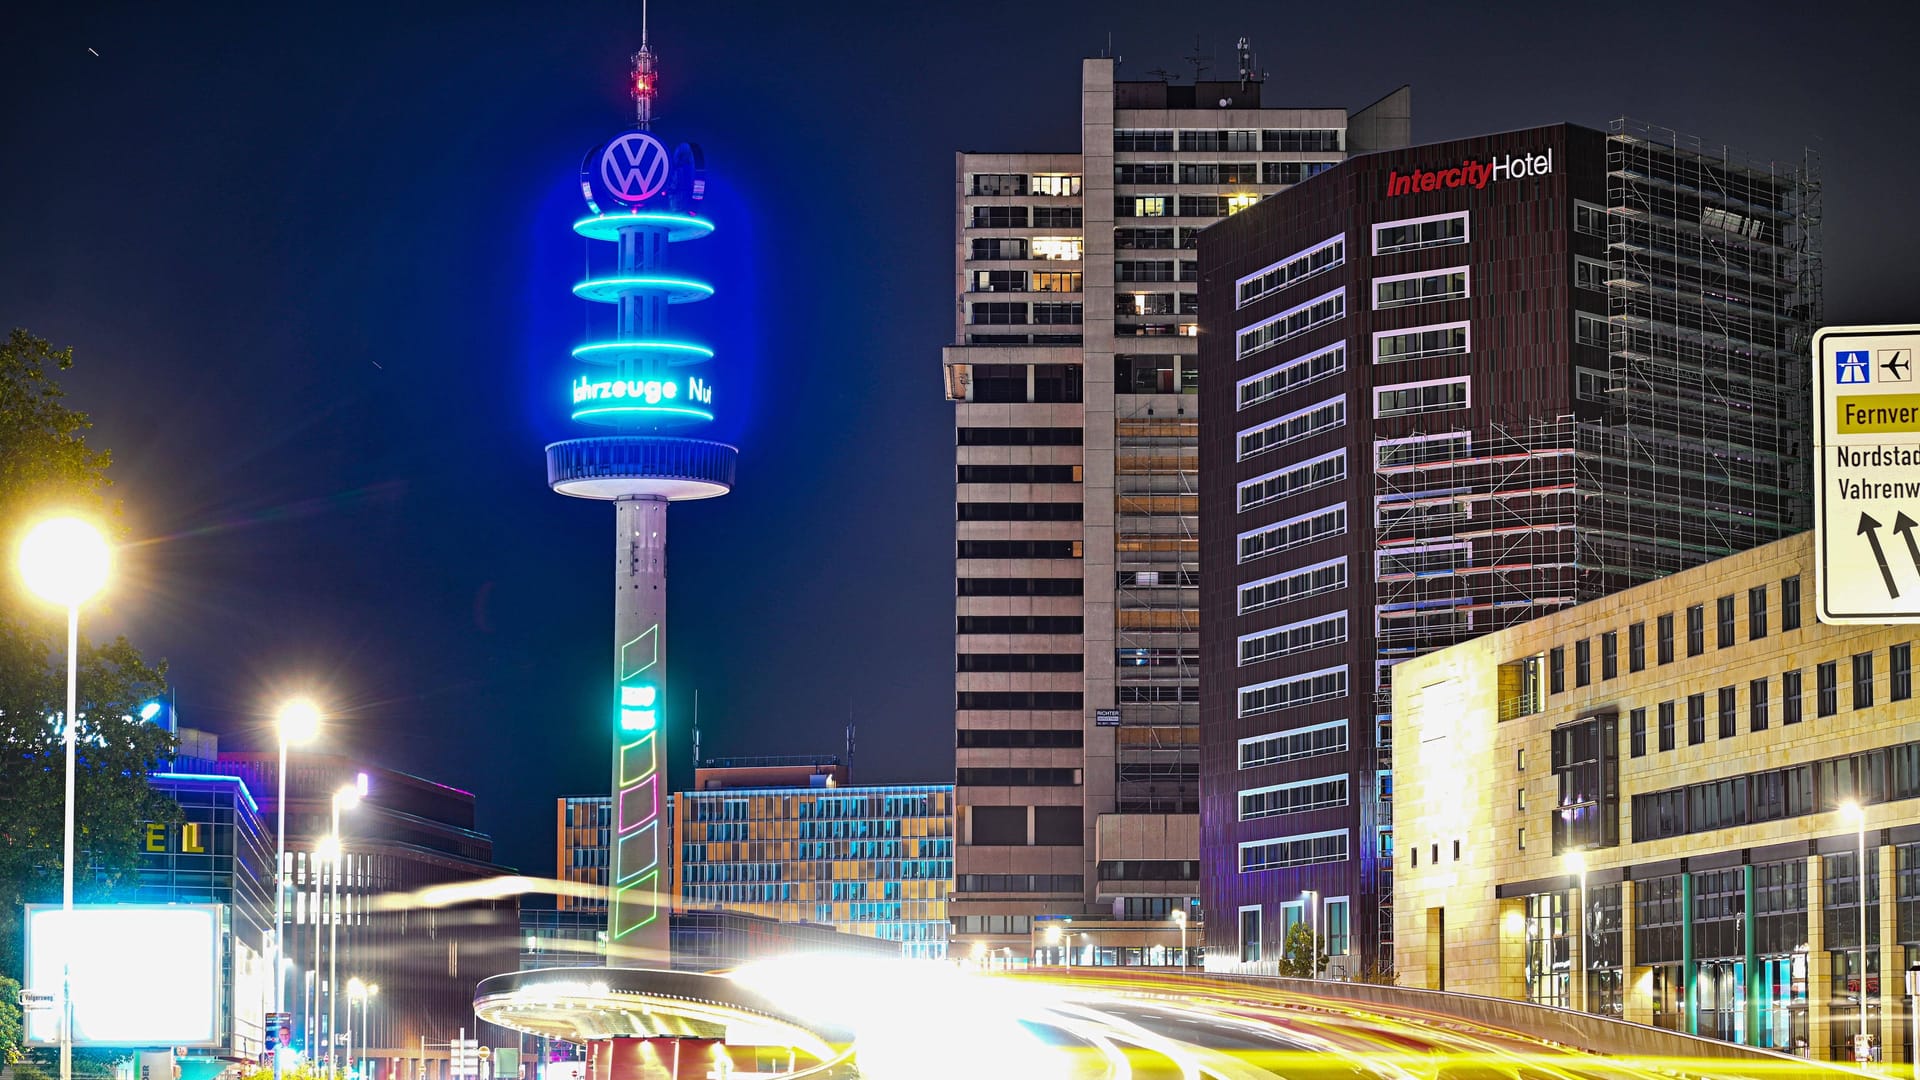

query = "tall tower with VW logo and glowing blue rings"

[{"left": 547, "top": 29, "right": 739, "bottom": 967}]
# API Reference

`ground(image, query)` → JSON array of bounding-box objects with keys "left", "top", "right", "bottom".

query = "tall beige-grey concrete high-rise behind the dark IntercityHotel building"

[{"left": 943, "top": 54, "right": 1407, "bottom": 963}]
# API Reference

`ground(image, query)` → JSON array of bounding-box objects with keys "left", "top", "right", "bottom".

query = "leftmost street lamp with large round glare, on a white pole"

[{"left": 19, "top": 517, "right": 113, "bottom": 1080}]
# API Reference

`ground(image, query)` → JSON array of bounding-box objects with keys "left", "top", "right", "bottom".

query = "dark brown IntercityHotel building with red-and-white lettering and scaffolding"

[{"left": 1190, "top": 121, "right": 1818, "bottom": 972}]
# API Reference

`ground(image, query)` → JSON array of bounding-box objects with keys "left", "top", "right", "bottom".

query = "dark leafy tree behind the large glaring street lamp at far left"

[{"left": 0, "top": 331, "right": 179, "bottom": 972}]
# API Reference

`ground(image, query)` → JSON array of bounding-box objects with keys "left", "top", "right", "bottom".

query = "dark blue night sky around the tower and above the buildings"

[{"left": 0, "top": 0, "right": 1920, "bottom": 871}]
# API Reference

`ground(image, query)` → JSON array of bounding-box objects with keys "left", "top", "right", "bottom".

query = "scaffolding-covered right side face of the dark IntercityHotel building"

[{"left": 1578, "top": 119, "right": 1822, "bottom": 588}]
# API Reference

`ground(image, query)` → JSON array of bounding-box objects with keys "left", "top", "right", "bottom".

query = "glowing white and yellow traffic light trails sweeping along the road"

[{"left": 732, "top": 957, "right": 1884, "bottom": 1080}]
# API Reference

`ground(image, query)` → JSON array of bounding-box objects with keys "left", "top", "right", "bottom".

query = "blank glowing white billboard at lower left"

[{"left": 25, "top": 903, "right": 225, "bottom": 1047}]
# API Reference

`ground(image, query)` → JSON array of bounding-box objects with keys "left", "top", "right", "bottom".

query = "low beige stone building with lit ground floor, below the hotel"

[{"left": 1394, "top": 532, "right": 1920, "bottom": 1061}]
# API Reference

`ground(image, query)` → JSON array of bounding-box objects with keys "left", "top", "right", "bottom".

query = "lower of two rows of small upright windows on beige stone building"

[{"left": 1628, "top": 644, "right": 1914, "bottom": 757}]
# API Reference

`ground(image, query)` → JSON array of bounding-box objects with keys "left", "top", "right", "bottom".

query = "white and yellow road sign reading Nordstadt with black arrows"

[{"left": 1812, "top": 327, "right": 1920, "bottom": 623}]
